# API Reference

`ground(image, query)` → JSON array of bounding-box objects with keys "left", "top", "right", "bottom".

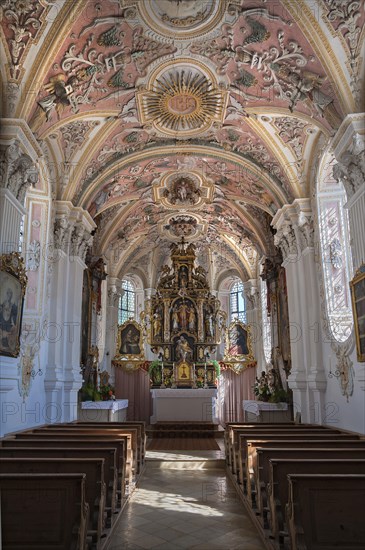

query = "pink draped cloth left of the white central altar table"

[{"left": 115, "top": 368, "right": 152, "bottom": 424}]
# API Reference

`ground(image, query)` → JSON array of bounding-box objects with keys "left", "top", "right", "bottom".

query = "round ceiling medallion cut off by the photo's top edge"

[{"left": 134, "top": 0, "right": 227, "bottom": 40}]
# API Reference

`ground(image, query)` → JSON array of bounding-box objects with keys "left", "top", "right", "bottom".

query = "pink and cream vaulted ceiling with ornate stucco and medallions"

[{"left": 0, "top": 0, "right": 365, "bottom": 284}]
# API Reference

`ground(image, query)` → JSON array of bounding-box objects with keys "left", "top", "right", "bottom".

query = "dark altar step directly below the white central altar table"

[{"left": 146, "top": 422, "right": 224, "bottom": 439}]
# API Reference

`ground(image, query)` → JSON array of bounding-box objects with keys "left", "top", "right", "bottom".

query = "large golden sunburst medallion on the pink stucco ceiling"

[{"left": 137, "top": 64, "right": 228, "bottom": 139}]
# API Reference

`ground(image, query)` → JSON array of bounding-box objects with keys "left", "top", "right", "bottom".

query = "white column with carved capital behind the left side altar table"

[{"left": 45, "top": 201, "right": 95, "bottom": 422}]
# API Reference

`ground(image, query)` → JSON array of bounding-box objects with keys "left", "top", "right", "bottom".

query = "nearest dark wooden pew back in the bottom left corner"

[{"left": 0, "top": 473, "right": 89, "bottom": 550}]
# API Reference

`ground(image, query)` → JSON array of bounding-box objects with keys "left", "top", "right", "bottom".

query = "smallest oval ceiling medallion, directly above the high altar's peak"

[{"left": 158, "top": 214, "right": 207, "bottom": 242}]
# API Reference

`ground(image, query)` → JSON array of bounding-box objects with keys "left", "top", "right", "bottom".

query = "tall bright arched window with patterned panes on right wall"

[{"left": 317, "top": 153, "right": 353, "bottom": 342}]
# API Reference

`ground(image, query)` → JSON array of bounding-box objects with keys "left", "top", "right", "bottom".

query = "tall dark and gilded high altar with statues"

[{"left": 145, "top": 239, "right": 226, "bottom": 389}]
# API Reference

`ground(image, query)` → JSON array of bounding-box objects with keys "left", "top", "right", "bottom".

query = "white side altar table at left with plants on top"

[{"left": 79, "top": 399, "right": 128, "bottom": 422}]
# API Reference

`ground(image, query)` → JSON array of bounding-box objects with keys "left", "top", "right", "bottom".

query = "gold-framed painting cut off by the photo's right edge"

[{"left": 350, "top": 264, "right": 365, "bottom": 363}]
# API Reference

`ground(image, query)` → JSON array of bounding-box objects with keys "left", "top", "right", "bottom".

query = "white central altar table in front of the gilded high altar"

[{"left": 151, "top": 388, "right": 217, "bottom": 424}]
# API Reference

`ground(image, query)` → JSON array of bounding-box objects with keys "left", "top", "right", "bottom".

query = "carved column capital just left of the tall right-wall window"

[{"left": 271, "top": 199, "right": 314, "bottom": 260}]
